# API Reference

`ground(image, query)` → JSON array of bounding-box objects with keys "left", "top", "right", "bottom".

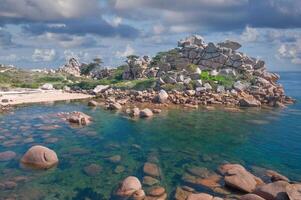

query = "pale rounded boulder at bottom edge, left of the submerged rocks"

[{"left": 115, "top": 176, "right": 145, "bottom": 199}]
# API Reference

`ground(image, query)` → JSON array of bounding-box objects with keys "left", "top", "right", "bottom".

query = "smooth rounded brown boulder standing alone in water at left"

[{"left": 21, "top": 145, "right": 59, "bottom": 169}]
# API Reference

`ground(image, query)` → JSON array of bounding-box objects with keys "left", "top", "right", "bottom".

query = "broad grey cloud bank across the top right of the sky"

[{"left": 110, "top": 0, "right": 301, "bottom": 30}]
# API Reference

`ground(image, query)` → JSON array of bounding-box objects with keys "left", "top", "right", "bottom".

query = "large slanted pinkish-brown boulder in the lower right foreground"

[{"left": 220, "top": 164, "right": 263, "bottom": 193}]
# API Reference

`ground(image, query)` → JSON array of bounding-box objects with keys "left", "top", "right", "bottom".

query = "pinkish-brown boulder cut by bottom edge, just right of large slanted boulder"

[{"left": 254, "top": 181, "right": 290, "bottom": 200}]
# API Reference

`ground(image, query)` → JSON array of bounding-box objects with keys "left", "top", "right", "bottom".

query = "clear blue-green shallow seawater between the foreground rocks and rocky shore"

[{"left": 0, "top": 73, "right": 301, "bottom": 199}]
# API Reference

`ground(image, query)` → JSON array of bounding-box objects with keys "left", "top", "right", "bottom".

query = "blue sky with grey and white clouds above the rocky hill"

[{"left": 0, "top": 0, "right": 301, "bottom": 71}]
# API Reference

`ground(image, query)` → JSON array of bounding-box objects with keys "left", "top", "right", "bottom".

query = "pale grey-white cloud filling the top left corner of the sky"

[{"left": 0, "top": 0, "right": 100, "bottom": 23}]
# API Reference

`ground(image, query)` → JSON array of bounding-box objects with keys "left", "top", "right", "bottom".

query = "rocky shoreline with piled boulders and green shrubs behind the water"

[{"left": 2, "top": 35, "right": 294, "bottom": 112}]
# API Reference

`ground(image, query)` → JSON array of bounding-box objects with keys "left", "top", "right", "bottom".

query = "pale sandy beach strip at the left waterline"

[{"left": 0, "top": 90, "right": 93, "bottom": 105}]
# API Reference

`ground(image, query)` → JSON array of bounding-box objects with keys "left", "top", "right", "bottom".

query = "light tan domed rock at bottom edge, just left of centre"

[{"left": 116, "top": 176, "right": 144, "bottom": 197}]
